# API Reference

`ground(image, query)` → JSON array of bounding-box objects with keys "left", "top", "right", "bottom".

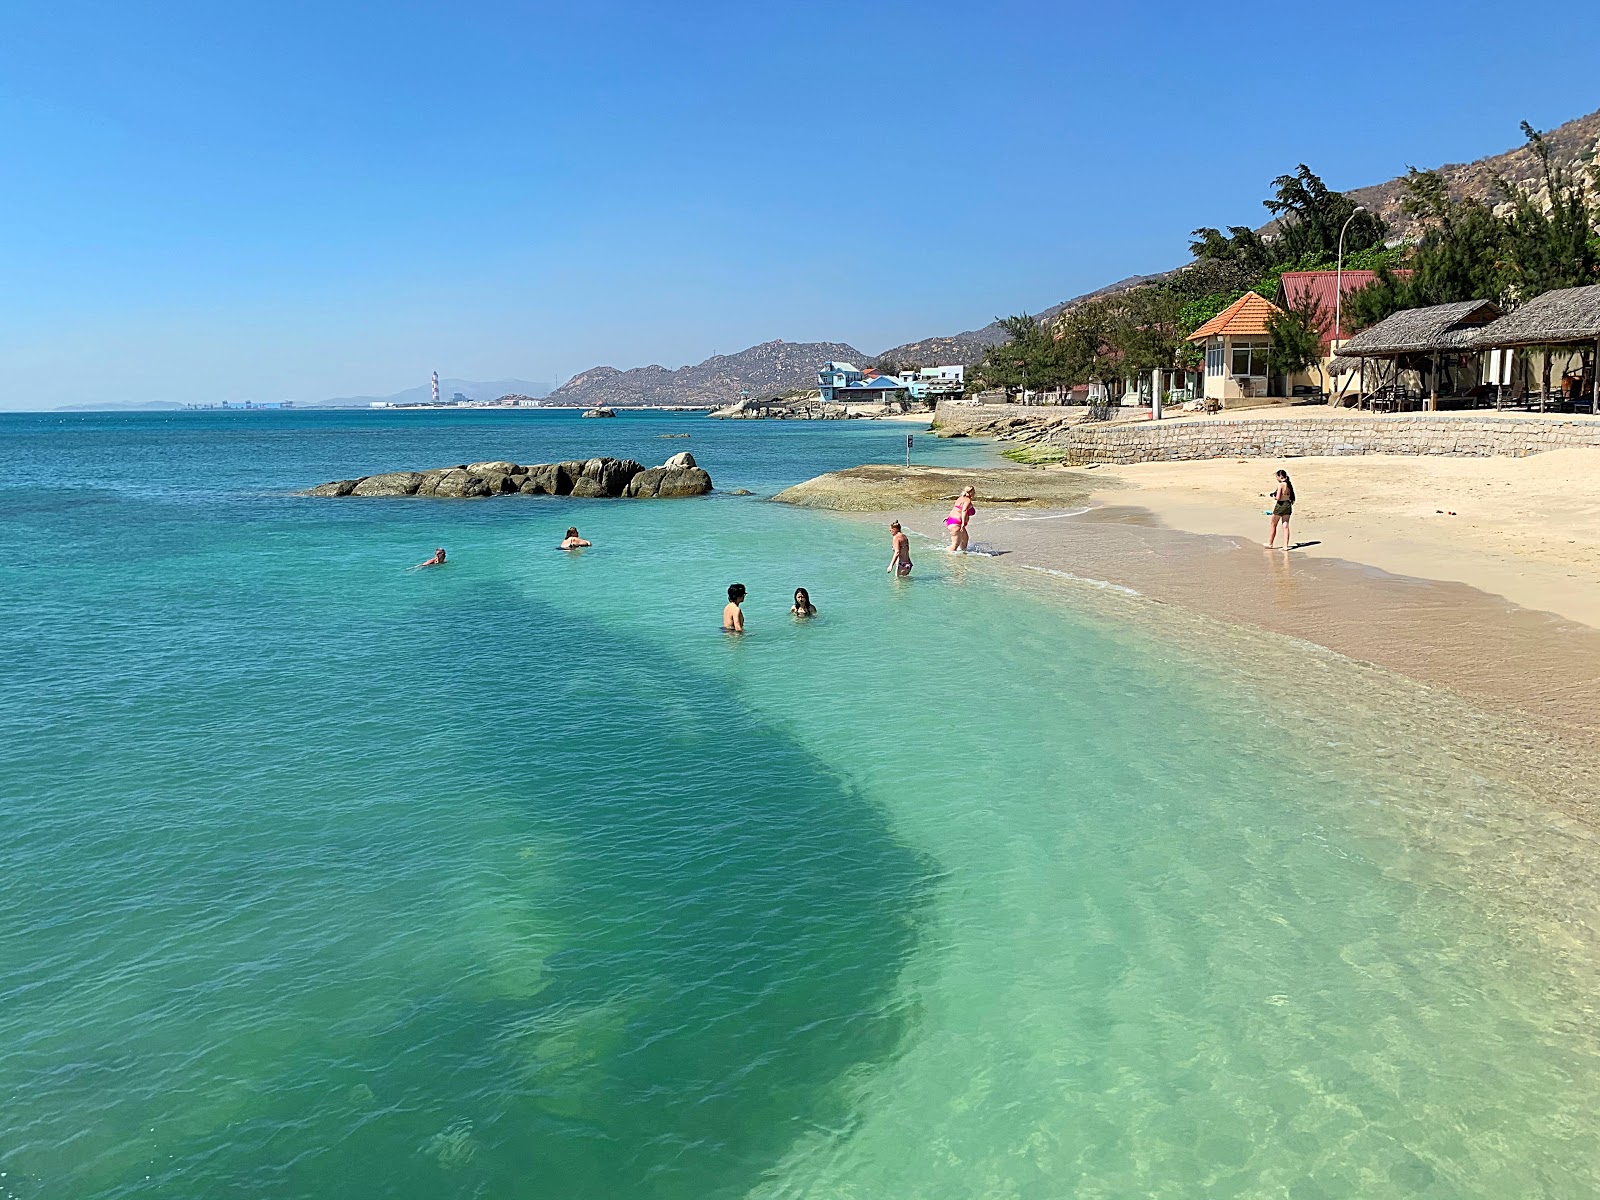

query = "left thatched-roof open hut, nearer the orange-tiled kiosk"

[{"left": 1339, "top": 301, "right": 1501, "bottom": 413}]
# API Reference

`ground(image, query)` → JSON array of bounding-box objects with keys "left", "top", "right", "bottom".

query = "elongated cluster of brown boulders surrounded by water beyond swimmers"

[{"left": 306, "top": 451, "right": 712, "bottom": 499}]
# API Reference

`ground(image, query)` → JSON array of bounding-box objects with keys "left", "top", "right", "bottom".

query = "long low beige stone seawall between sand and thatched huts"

[{"left": 1046, "top": 413, "right": 1600, "bottom": 466}]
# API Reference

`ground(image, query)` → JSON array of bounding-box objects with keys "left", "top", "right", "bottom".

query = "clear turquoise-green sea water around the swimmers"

[{"left": 0, "top": 413, "right": 1600, "bottom": 1200}]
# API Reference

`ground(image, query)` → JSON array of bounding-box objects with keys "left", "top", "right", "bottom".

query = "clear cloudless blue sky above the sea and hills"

[{"left": 0, "top": 0, "right": 1600, "bottom": 408}]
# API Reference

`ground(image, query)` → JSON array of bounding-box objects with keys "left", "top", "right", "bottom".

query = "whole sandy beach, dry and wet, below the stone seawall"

[{"left": 790, "top": 450, "right": 1600, "bottom": 824}]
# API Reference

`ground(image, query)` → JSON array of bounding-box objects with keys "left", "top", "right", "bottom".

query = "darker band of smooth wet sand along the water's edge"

[{"left": 902, "top": 506, "right": 1600, "bottom": 822}]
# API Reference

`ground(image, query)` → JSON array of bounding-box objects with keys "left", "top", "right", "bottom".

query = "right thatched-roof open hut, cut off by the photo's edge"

[{"left": 1477, "top": 285, "right": 1600, "bottom": 414}]
